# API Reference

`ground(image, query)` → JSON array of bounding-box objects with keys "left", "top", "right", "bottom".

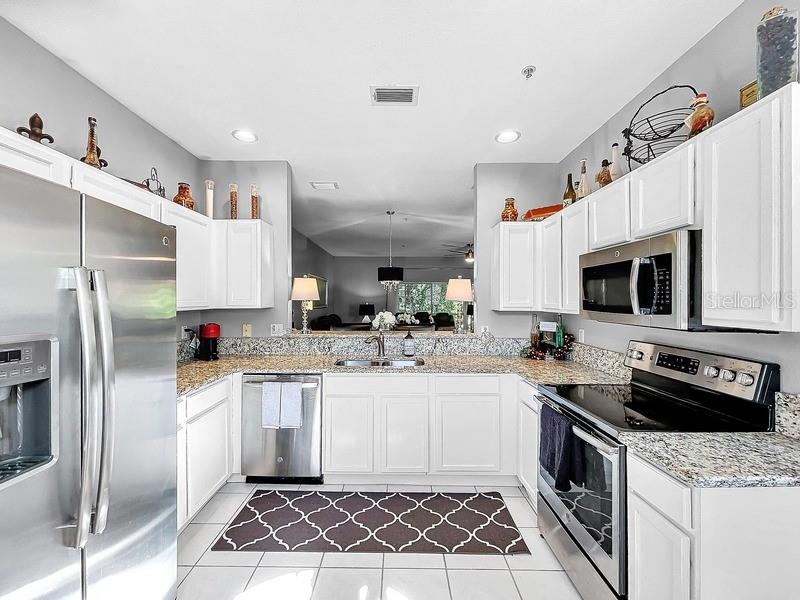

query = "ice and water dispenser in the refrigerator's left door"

[{"left": 0, "top": 338, "right": 58, "bottom": 487}]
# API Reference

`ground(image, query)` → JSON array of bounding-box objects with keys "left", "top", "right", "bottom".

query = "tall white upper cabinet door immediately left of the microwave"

[{"left": 561, "top": 202, "right": 589, "bottom": 314}]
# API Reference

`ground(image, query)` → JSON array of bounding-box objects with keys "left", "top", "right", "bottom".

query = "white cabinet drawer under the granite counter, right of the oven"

[{"left": 628, "top": 454, "right": 692, "bottom": 529}]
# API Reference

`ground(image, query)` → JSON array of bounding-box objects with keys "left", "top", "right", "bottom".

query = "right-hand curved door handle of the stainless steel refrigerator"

[{"left": 92, "top": 270, "right": 116, "bottom": 534}]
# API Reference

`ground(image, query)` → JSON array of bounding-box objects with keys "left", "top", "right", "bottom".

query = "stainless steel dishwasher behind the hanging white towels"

[{"left": 242, "top": 373, "right": 322, "bottom": 483}]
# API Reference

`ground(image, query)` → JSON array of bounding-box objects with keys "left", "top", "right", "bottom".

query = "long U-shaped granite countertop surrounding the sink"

[{"left": 177, "top": 355, "right": 627, "bottom": 395}]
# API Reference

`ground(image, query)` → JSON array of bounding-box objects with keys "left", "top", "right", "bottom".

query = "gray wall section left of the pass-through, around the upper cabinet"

[{"left": 178, "top": 161, "right": 292, "bottom": 337}]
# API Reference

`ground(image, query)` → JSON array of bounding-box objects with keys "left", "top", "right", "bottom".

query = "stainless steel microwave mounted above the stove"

[{"left": 579, "top": 231, "right": 702, "bottom": 329}]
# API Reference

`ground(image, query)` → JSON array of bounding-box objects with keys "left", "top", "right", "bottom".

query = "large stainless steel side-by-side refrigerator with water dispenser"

[{"left": 0, "top": 169, "right": 177, "bottom": 600}]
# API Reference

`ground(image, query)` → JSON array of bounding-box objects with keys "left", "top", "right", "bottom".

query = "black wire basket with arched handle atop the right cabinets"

[{"left": 622, "top": 85, "right": 697, "bottom": 169}]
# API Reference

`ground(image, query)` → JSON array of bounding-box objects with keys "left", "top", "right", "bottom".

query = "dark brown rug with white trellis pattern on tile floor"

[{"left": 212, "top": 490, "right": 528, "bottom": 554}]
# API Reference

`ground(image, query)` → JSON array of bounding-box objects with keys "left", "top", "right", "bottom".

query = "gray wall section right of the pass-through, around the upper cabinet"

[{"left": 475, "top": 163, "right": 563, "bottom": 337}]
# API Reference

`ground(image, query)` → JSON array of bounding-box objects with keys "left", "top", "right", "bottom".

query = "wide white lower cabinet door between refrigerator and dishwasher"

[{"left": 186, "top": 399, "right": 230, "bottom": 517}]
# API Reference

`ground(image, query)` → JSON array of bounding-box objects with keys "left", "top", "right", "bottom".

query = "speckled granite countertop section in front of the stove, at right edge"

[{"left": 620, "top": 432, "right": 800, "bottom": 488}]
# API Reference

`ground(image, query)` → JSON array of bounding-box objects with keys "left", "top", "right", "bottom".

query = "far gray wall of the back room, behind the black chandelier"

[{"left": 329, "top": 256, "right": 472, "bottom": 322}]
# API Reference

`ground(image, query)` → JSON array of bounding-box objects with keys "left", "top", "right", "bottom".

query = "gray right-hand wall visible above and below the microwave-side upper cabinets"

[{"left": 558, "top": 0, "right": 800, "bottom": 392}]
